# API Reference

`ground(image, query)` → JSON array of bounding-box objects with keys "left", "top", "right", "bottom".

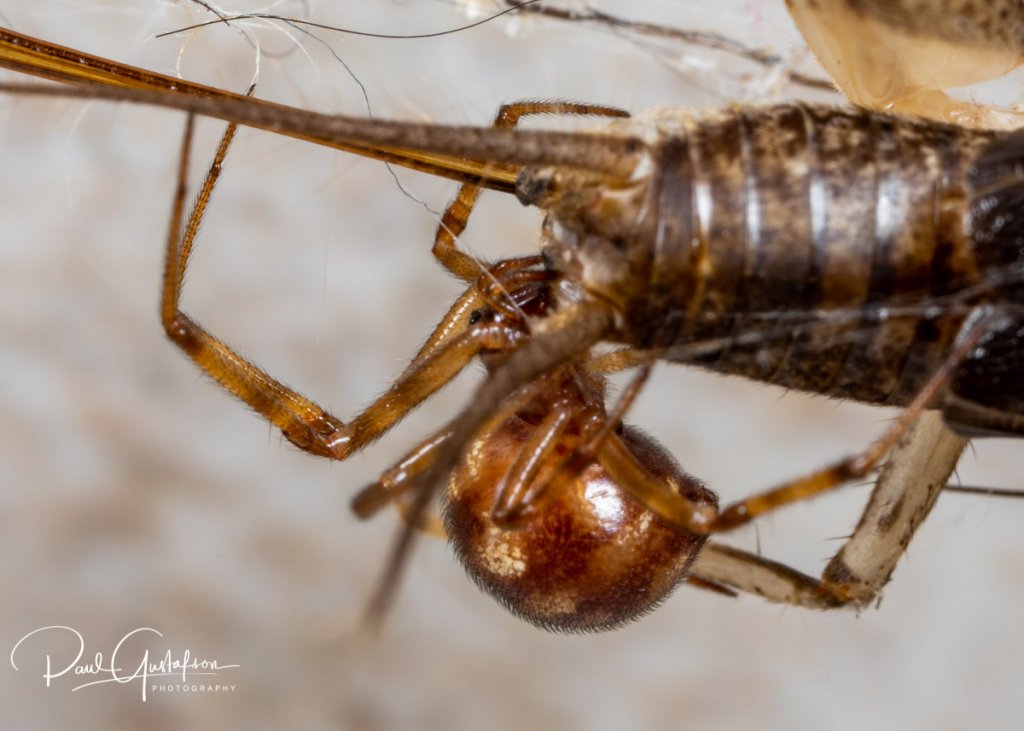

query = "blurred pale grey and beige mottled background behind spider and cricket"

[{"left": 0, "top": 0, "right": 1024, "bottom": 729}]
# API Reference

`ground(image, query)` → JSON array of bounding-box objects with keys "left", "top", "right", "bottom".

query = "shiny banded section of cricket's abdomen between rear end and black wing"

[{"left": 677, "top": 105, "right": 991, "bottom": 404}]
